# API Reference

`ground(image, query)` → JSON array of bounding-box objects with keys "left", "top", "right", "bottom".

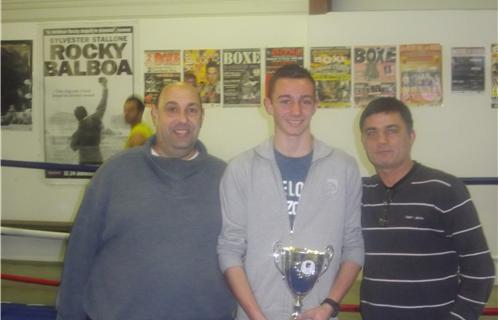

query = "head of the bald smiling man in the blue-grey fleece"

[{"left": 152, "top": 84, "right": 204, "bottom": 159}]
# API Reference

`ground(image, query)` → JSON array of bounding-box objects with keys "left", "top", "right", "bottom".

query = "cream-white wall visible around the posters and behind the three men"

[{"left": 2, "top": 10, "right": 498, "bottom": 270}]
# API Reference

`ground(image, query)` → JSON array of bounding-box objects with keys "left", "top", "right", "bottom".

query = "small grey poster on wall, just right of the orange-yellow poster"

[{"left": 451, "top": 47, "right": 484, "bottom": 92}]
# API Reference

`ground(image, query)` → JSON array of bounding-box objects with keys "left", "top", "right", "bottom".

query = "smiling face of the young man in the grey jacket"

[{"left": 265, "top": 78, "right": 318, "bottom": 138}]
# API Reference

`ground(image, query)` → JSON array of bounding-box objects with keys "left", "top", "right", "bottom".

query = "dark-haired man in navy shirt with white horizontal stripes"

[{"left": 360, "top": 97, "right": 495, "bottom": 320}]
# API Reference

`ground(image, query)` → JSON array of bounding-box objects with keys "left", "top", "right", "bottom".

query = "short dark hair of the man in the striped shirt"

[{"left": 360, "top": 97, "right": 413, "bottom": 132}]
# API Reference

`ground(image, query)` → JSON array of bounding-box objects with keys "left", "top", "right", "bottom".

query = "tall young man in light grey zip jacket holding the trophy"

[{"left": 218, "top": 65, "right": 363, "bottom": 320}]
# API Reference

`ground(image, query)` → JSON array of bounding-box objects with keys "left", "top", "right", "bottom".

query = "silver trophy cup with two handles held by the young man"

[{"left": 273, "top": 241, "right": 334, "bottom": 319}]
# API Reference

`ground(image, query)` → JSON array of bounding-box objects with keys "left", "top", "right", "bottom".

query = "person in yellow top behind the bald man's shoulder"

[{"left": 123, "top": 96, "right": 154, "bottom": 149}]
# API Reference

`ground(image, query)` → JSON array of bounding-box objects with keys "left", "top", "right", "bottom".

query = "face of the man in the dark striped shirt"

[{"left": 361, "top": 112, "right": 415, "bottom": 171}]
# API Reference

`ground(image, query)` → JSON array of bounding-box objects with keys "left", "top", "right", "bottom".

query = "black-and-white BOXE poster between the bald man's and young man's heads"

[{"left": 223, "top": 49, "right": 261, "bottom": 107}]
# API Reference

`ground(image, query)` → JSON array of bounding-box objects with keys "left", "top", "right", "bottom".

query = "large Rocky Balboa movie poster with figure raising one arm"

[{"left": 43, "top": 25, "right": 134, "bottom": 178}]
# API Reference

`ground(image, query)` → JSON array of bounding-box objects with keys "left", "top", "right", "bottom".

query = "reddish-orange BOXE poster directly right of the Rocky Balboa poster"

[{"left": 144, "top": 50, "right": 182, "bottom": 107}]
